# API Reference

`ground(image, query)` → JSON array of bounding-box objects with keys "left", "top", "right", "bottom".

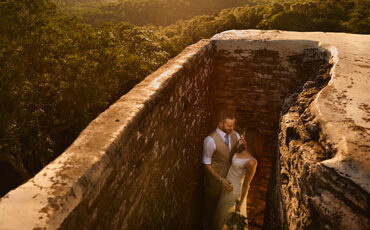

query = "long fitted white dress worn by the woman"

[{"left": 214, "top": 154, "right": 253, "bottom": 230}]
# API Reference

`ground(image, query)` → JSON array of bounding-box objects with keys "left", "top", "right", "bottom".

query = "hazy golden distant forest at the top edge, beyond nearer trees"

[{"left": 55, "top": 0, "right": 267, "bottom": 25}]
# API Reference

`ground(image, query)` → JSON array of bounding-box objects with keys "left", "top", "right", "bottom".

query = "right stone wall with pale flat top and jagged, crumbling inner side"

[{"left": 208, "top": 31, "right": 370, "bottom": 229}]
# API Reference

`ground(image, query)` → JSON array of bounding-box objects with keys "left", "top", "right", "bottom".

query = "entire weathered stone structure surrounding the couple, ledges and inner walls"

[{"left": 0, "top": 30, "right": 370, "bottom": 229}]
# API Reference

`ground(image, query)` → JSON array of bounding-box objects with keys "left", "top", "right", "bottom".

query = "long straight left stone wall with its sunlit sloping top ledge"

[{"left": 0, "top": 41, "right": 213, "bottom": 229}]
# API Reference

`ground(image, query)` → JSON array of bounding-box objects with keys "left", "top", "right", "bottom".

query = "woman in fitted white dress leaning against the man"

[{"left": 214, "top": 129, "right": 257, "bottom": 229}]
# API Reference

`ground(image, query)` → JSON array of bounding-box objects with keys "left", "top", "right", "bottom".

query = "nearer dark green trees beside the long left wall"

[{"left": 0, "top": 0, "right": 169, "bottom": 191}]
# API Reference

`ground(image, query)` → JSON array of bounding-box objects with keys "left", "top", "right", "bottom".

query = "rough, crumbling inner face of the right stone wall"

[{"left": 277, "top": 49, "right": 370, "bottom": 230}]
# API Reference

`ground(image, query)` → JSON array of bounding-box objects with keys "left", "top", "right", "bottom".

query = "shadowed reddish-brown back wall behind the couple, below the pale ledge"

[{"left": 212, "top": 37, "right": 329, "bottom": 229}]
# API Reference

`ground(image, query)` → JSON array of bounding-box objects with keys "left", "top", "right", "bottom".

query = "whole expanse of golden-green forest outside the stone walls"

[{"left": 0, "top": 0, "right": 370, "bottom": 196}]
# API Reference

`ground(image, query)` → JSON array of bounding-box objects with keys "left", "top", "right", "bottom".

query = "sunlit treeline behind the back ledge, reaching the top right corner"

[{"left": 161, "top": 0, "right": 370, "bottom": 54}]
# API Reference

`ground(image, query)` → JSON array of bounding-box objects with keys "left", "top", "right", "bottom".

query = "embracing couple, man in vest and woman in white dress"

[{"left": 202, "top": 110, "right": 257, "bottom": 229}]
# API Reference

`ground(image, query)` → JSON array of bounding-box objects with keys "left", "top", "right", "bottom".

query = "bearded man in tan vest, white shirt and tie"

[{"left": 202, "top": 111, "right": 245, "bottom": 229}]
